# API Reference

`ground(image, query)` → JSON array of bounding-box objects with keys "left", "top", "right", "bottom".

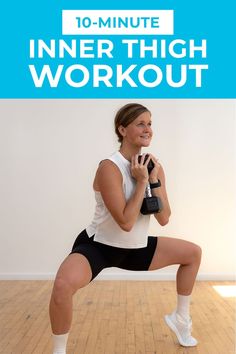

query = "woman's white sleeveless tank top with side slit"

[{"left": 86, "top": 151, "right": 150, "bottom": 248}]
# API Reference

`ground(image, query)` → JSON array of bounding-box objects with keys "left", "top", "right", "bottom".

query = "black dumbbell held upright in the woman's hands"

[{"left": 138, "top": 155, "right": 162, "bottom": 215}]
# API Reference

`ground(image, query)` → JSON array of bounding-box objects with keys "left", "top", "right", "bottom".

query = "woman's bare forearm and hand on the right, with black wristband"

[{"left": 149, "top": 154, "right": 171, "bottom": 226}]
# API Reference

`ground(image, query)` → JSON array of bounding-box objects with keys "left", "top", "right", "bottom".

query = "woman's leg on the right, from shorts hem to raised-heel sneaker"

[{"left": 149, "top": 237, "right": 201, "bottom": 347}]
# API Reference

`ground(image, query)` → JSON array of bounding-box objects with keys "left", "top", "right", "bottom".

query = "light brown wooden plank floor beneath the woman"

[{"left": 0, "top": 281, "right": 235, "bottom": 354}]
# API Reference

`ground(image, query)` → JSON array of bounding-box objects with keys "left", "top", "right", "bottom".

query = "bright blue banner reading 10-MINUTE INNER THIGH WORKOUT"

[{"left": 0, "top": 0, "right": 236, "bottom": 98}]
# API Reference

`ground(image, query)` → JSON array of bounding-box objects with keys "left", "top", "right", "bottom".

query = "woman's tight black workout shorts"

[{"left": 71, "top": 230, "right": 158, "bottom": 279}]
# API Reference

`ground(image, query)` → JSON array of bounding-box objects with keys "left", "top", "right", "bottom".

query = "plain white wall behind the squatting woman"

[{"left": 0, "top": 100, "right": 236, "bottom": 279}]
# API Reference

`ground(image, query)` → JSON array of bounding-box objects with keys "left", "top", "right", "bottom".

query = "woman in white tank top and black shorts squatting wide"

[{"left": 50, "top": 103, "right": 201, "bottom": 354}]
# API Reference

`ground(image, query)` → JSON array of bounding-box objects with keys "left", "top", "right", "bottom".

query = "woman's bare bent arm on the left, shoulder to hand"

[{"left": 96, "top": 155, "right": 149, "bottom": 232}]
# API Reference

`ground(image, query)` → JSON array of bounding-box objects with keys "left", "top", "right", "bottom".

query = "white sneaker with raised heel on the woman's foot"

[{"left": 165, "top": 311, "right": 198, "bottom": 347}]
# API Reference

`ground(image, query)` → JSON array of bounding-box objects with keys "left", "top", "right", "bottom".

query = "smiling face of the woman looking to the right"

[{"left": 123, "top": 112, "right": 153, "bottom": 147}]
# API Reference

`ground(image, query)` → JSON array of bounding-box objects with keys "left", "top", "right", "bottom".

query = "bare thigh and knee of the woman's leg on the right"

[{"left": 149, "top": 237, "right": 201, "bottom": 270}]
